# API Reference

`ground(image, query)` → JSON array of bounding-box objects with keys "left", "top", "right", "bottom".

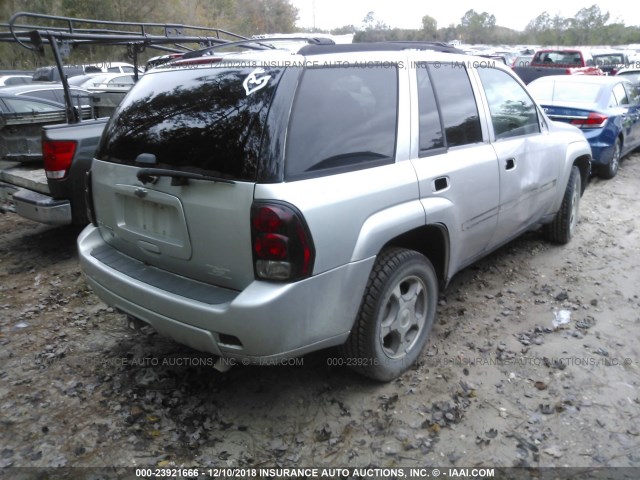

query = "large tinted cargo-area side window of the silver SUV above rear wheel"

[{"left": 285, "top": 65, "right": 398, "bottom": 178}]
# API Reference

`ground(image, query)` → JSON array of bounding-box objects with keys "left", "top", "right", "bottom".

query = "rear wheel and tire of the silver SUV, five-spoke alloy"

[{"left": 340, "top": 247, "right": 438, "bottom": 382}]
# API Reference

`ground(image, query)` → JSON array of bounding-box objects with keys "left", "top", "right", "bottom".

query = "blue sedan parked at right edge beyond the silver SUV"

[{"left": 527, "top": 75, "right": 640, "bottom": 178}]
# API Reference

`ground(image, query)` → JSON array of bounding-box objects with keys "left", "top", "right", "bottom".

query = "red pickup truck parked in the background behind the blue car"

[{"left": 513, "top": 49, "right": 604, "bottom": 84}]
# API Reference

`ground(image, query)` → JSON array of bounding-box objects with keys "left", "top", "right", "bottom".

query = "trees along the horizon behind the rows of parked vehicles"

[{"left": 0, "top": 0, "right": 640, "bottom": 69}]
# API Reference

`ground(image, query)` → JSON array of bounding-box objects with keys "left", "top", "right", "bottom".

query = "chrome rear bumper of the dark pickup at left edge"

[{"left": 0, "top": 183, "right": 72, "bottom": 225}]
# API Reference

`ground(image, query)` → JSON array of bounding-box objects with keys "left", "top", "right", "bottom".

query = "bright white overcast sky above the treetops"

[{"left": 291, "top": 0, "right": 640, "bottom": 31}]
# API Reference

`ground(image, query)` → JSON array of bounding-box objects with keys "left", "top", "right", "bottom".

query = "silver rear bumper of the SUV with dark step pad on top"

[{"left": 78, "top": 225, "right": 375, "bottom": 363}]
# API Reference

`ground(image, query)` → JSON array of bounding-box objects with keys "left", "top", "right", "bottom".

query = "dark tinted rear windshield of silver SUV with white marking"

[{"left": 97, "top": 64, "right": 282, "bottom": 181}]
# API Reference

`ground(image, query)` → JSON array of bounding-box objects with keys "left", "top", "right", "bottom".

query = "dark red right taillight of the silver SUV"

[{"left": 251, "top": 203, "right": 315, "bottom": 281}]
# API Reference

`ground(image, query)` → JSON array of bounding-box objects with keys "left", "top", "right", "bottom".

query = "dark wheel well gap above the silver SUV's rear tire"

[{"left": 385, "top": 224, "right": 449, "bottom": 288}]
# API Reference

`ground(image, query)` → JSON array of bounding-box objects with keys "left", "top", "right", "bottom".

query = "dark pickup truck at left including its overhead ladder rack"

[{"left": 0, "top": 12, "right": 247, "bottom": 225}]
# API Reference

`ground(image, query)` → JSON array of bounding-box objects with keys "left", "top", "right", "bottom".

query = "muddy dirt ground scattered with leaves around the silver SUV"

[{"left": 0, "top": 154, "right": 640, "bottom": 471}]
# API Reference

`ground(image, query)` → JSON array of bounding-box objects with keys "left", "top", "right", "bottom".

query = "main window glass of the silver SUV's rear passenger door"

[{"left": 429, "top": 63, "right": 482, "bottom": 147}]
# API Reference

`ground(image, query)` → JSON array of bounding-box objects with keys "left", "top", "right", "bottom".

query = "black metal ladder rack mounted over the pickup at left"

[{"left": 0, "top": 12, "right": 248, "bottom": 123}]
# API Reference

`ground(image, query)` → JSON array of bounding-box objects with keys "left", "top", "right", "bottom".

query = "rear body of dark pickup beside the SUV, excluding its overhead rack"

[{"left": 0, "top": 118, "right": 108, "bottom": 225}]
